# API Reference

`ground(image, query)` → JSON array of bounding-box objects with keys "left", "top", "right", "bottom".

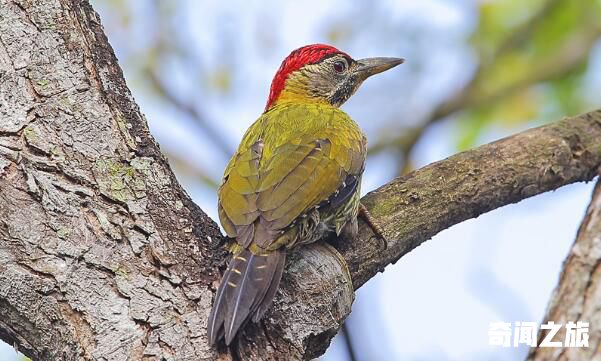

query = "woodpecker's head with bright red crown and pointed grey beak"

[{"left": 265, "top": 44, "right": 404, "bottom": 111}]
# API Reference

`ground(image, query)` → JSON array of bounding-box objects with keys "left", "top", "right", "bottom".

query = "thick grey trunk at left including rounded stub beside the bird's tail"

[{"left": 0, "top": 0, "right": 353, "bottom": 360}]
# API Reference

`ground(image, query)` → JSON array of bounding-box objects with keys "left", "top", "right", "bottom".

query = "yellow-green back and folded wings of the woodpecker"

[{"left": 219, "top": 105, "right": 366, "bottom": 248}]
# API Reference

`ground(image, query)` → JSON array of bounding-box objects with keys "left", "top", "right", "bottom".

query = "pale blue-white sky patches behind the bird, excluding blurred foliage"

[{"left": 0, "top": 0, "right": 601, "bottom": 361}]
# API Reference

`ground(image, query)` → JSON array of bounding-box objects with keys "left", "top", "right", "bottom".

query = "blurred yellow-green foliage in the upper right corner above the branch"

[{"left": 457, "top": 0, "right": 601, "bottom": 149}]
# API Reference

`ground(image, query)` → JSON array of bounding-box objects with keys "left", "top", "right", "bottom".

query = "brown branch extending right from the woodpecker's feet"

[{"left": 346, "top": 111, "right": 601, "bottom": 288}]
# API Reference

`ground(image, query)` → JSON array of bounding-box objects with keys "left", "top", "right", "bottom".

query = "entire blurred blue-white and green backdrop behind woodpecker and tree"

[{"left": 0, "top": 0, "right": 601, "bottom": 361}]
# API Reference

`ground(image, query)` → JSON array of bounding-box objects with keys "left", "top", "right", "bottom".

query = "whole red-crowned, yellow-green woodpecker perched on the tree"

[{"left": 208, "top": 44, "right": 404, "bottom": 345}]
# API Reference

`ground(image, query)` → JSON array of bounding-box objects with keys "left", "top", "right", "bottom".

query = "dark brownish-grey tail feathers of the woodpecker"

[{"left": 208, "top": 249, "right": 286, "bottom": 345}]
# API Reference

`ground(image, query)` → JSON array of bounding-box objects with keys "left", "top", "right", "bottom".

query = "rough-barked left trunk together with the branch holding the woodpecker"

[{"left": 0, "top": 0, "right": 601, "bottom": 360}]
